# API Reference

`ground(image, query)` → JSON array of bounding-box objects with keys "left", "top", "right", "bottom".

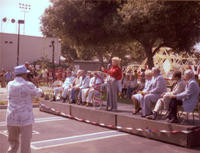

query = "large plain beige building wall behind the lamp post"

[{"left": 0, "top": 33, "right": 61, "bottom": 70}]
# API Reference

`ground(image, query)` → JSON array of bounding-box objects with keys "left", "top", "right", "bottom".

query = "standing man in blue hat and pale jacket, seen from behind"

[{"left": 6, "top": 65, "right": 42, "bottom": 153}]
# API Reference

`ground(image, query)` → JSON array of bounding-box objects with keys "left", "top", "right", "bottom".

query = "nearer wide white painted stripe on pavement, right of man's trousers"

[{"left": 31, "top": 131, "right": 128, "bottom": 150}]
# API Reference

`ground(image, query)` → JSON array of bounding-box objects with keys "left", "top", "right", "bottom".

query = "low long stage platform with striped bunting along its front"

[{"left": 40, "top": 100, "right": 200, "bottom": 148}]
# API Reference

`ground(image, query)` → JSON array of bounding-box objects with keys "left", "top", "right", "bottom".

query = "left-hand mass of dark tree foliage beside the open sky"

[{"left": 41, "top": 0, "right": 125, "bottom": 62}]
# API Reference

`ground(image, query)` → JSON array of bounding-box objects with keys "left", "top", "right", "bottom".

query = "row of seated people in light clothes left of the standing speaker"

[{"left": 52, "top": 70, "right": 104, "bottom": 106}]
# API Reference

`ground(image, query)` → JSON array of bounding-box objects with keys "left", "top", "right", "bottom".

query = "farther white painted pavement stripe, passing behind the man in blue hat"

[{"left": 0, "top": 117, "right": 69, "bottom": 127}]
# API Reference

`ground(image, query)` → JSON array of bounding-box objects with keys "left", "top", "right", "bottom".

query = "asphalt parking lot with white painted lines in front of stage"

[{"left": 0, "top": 108, "right": 200, "bottom": 153}]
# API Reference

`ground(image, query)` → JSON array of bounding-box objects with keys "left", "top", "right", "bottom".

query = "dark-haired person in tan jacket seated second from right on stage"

[{"left": 148, "top": 71, "right": 186, "bottom": 120}]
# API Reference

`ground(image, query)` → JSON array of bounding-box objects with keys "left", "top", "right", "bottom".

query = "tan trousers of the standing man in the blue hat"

[{"left": 7, "top": 124, "right": 32, "bottom": 153}]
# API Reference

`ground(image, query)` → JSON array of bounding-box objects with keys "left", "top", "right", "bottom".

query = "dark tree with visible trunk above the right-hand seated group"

[{"left": 120, "top": 0, "right": 200, "bottom": 67}]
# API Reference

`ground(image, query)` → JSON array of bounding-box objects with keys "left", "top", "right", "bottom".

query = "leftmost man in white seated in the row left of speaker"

[{"left": 62, "top": 71, "right": 75, "bottom": 102}]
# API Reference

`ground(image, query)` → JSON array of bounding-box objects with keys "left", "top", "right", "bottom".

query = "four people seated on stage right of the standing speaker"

[{"left": 132, "top": 67, "right": 200, "bottom": 123}]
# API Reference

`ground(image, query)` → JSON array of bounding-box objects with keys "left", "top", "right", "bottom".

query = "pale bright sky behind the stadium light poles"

[{"left": 0, "top": 0, "right": 51, "bottom": 36}]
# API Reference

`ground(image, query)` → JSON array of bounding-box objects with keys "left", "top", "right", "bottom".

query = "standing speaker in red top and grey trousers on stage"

[{"left": 101, "top": 57, "right": 122, "bottom": 111}]
